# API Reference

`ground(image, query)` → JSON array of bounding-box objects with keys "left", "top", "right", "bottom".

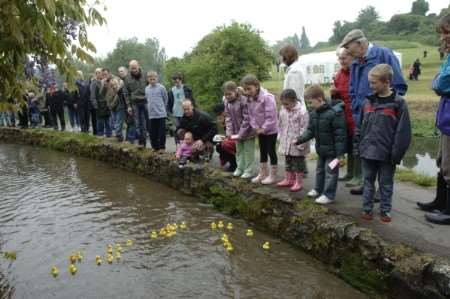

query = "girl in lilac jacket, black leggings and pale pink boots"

[{"left": 241, "top": 75, "right": 278, "bottom": 185}]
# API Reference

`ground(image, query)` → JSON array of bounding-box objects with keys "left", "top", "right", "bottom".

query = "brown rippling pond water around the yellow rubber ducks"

[{"left": 0, "top": 144, "right": 366, "bottom": 299}]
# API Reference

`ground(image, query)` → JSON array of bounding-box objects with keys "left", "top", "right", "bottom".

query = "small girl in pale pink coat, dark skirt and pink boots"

[{"left": 277, "top": 89, "right": 309, "bottom": 192}]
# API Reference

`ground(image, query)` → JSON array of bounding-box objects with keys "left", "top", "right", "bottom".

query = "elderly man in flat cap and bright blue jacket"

[{"left": 340, "top": 29, "right": 408, "bottom": 195}]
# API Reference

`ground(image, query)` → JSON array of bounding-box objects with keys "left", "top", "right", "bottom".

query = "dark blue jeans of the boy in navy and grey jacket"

[{"left": 361, "top": 158, "right": 396, "bottom": 213}]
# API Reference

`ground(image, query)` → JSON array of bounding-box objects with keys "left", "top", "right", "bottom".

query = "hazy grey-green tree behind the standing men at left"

[{"left": 101, "top": 37, "right": 167, "bottom": 73}]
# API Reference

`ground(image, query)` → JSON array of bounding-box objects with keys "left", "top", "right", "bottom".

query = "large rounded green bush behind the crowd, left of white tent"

[{"left": 164, "top": 22, "right": 274, "bottom": 110}]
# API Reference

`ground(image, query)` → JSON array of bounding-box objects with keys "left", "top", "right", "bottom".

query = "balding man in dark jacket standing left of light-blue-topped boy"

[{"left": 123, "top": 60, "right": 148, "bottom": 147}]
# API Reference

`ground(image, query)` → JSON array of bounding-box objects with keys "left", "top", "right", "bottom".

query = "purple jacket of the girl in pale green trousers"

[{"left": 224, "top": 96, "right": 256, "bottom": 139}]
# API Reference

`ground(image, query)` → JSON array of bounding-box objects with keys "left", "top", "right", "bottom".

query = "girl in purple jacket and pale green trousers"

[{"left": 223, "top": 81, "right": 256, "bottom": 179}]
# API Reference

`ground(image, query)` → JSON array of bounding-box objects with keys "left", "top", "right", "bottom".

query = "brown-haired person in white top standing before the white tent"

[{"left": 280, "top": 45, "right": 305, "bottom": 106}]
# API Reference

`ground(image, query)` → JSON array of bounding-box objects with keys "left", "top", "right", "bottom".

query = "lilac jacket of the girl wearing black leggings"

[{"left": 247, "top": 88, "right": 278, "bottom": 135}]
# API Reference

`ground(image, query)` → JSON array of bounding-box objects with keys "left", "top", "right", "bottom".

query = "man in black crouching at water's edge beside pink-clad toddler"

[{"left": 177, "top": 99, "right": 217, "bottom": 161}]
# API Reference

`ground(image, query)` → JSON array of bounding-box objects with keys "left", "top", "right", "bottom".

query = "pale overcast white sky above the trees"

[{"left": 88, "top": 0, "right": 449, "bottom": 58}]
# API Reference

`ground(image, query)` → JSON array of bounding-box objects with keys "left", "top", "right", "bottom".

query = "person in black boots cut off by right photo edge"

[{"left": 417, "top": 14, "right": 450, "bottom": 225}]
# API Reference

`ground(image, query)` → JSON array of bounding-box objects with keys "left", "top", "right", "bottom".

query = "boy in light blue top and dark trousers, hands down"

[{"left": 145, "top": 71, "right": 168, "bottom": 153}]
